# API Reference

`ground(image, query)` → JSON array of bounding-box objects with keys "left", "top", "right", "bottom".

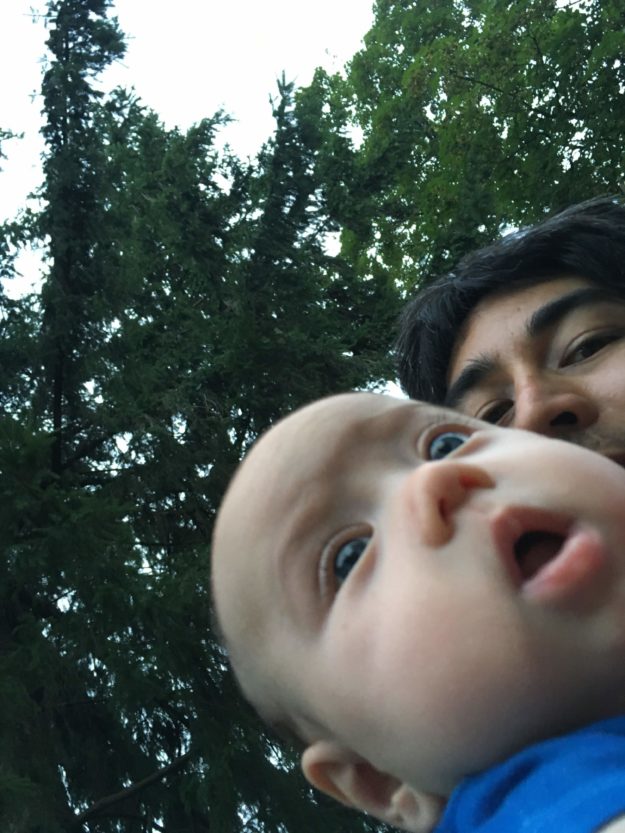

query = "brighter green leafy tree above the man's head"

[{"left": 316, "top": 0, "right": 625, "bottom": 290}]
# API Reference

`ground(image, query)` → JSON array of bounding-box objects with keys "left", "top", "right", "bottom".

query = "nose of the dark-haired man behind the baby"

[{"left": 513, "top": 378, "right": 599, "bottom": 439}]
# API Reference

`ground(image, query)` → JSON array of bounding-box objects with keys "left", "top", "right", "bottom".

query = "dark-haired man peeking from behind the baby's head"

[{"left": 397, "top": 198, "right": 625, "bottom": 456}]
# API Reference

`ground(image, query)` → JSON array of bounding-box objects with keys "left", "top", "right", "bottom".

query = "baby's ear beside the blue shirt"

[{"left": 301, "top": 740, "right": 445, "bottom": 833}]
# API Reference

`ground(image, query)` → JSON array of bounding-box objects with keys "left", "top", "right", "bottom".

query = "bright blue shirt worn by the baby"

[{"left": 436, "top": 717, "right": 625, "bottom": 833}]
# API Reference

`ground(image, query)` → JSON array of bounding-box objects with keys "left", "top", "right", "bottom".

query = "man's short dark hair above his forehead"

[{"left": 396, "top": 197, "right": 625, "bottom": 404}]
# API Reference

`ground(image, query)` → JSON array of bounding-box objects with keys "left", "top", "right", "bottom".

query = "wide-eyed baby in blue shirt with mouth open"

[{"left": 212, "top": 393, "right": 625, "bottom": 833}]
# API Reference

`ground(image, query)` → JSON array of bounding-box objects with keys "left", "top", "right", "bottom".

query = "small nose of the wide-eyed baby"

[{"left": 405, "top": 460, "right": 494, "bottom": 547}]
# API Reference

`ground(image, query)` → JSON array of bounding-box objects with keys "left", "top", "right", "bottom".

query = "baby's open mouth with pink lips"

[{"left": 492, "top": 507, "right": 607, "bottom": 602}]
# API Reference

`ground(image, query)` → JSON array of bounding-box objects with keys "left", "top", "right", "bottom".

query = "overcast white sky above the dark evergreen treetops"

[{"left": 0, "top": 0, "right": 373, "bottom": 224}]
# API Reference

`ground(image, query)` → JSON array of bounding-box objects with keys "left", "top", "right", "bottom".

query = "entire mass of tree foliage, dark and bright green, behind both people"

[{"left": 14, "top": 0, "right": 625, "bottom": 833}]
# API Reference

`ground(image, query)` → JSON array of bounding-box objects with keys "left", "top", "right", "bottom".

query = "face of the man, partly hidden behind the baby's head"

[{"left": 446, "top": 277, "right": 625, "bottom": 462}]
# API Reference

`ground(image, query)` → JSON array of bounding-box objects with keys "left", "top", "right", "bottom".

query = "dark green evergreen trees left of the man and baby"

[{"left": 0, "top": 0, "right": 397, "bottom": 833}]
